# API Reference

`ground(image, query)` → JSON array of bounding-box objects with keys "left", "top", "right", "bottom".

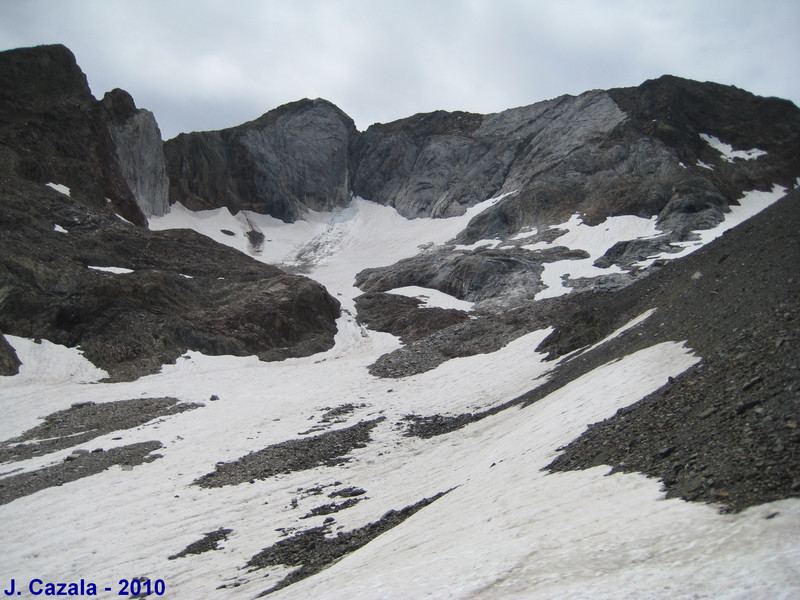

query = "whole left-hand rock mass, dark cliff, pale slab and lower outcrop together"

[{"left": 0, "top": 46, "right": 339, "bottom": 380}]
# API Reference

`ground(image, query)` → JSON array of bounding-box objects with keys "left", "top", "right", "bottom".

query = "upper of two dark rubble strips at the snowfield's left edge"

[{"left": 0, "top": 398, "right": 203, "bottom": 463}]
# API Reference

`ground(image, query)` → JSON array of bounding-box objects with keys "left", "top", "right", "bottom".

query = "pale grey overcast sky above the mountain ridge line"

[{"left": 0, "top": 0, "right": 800, "bottom": 139}]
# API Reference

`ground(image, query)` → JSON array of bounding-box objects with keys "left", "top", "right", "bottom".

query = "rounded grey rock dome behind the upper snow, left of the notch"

[{"left": 165, "top": 100, "right": 357, "bottom": 221}]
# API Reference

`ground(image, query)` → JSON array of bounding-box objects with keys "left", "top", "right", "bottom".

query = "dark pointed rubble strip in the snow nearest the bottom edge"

[{"left": 246, "top": 490, "right": 449, "bottom": 596}]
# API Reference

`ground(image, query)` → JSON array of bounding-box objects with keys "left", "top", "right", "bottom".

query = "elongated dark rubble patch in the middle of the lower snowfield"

[{"left": 194, "top": 417, "right": 383, "bottom": 487}]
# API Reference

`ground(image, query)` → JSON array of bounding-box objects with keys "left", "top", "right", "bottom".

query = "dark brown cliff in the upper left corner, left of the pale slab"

[{"left": 0, "top": 46, "right": 146, "bottom": 225}]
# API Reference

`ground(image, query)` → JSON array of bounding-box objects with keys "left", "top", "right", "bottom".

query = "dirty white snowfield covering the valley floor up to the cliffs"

[{"left": 0, "top": 190, "right": 800, "bottom": 600}]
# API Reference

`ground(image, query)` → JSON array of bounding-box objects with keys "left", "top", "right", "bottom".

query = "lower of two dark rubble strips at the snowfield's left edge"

[{"left": 0, "top": 441, "right": 162, "bottom": 504}]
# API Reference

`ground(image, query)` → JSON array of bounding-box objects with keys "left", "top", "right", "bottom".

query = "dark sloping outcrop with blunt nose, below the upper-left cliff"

[{"left": 0, "top": 176, "right": 339, "bottom": 380}]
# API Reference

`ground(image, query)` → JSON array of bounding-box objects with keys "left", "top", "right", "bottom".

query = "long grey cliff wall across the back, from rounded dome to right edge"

[{"left": 161, "top": 76, "right": 800, "bottom": 243}]
